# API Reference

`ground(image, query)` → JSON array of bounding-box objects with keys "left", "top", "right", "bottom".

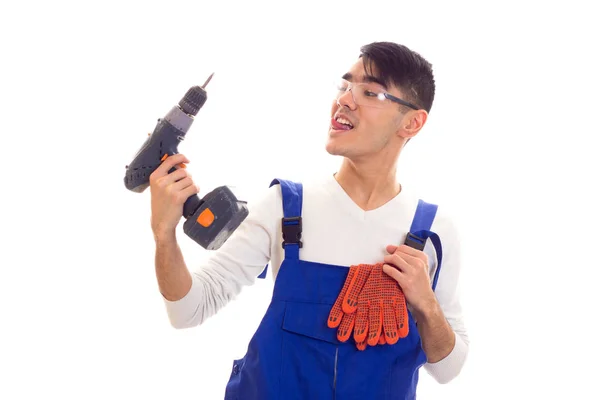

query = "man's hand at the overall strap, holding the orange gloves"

[{"left": 383, "top": 244, "right": 437, "bottom": 314}]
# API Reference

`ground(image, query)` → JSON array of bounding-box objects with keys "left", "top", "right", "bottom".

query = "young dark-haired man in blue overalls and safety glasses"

[{"left": 150, "top": 42, "right": 468, "bottom": 399}]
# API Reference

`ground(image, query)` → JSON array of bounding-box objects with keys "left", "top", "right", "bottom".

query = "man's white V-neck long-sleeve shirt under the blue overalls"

[{"left": 164, "top": 174, "right": 469, "bottom": 383}]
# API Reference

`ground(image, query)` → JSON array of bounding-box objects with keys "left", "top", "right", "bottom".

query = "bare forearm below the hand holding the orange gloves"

[{"left": 415, "top": 300, "right": 456, "bottom": 363}]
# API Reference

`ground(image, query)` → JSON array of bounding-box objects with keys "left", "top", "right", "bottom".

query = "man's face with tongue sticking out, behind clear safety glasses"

[{"left": 326, "top": 58, "right": 404, "bottom": 158}]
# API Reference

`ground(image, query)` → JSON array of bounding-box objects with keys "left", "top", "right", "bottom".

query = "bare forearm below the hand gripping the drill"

[{"left": 154, "top": 232, "right": 192, "bottom": 301}]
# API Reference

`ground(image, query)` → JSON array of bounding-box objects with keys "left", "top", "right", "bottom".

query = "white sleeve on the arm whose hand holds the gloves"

[{"left": 424, "top": 208, "right": 469, "bottom": 383}]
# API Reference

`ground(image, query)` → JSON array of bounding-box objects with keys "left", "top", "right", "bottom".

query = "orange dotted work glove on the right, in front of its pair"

[{"left": 354, "top": 263, "right": 408, "bottom": 350}]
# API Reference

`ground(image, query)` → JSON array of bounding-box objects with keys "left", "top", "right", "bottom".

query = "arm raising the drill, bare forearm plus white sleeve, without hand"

[{"left": 153, "top": 185, "right": 283, "bottom": 329}]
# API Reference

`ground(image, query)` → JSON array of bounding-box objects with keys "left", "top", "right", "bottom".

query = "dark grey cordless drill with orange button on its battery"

[{"left": 124, "top": 74, "right": 248, "bottom": 250}]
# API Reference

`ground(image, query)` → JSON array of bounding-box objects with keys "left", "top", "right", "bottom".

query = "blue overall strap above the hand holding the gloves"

[{"left": 404, "top": 199, "right": 442, "bottom": 291}]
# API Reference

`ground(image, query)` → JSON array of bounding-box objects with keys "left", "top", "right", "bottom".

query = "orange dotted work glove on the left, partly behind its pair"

[{"left": 327, "top": 264, "right": 373, "bottom": 342}]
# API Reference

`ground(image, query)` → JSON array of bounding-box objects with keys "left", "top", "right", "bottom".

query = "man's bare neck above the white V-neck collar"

[{"left": 335, "top": 152, "right": 401, "bottom": 211}]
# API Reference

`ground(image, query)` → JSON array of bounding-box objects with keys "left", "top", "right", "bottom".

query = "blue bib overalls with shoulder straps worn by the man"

[{"left": 225, "top": 179, "right": 441, "bottom": 400}]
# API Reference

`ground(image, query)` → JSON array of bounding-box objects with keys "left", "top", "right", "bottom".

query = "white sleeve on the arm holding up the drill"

[{"left": 163, "top": 185, "right": 283, "bottom": 329}]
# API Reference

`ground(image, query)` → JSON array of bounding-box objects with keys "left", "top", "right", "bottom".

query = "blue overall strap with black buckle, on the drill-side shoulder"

[{"left": 258, "top": 179, "right": 302, "bottom": 279}]
